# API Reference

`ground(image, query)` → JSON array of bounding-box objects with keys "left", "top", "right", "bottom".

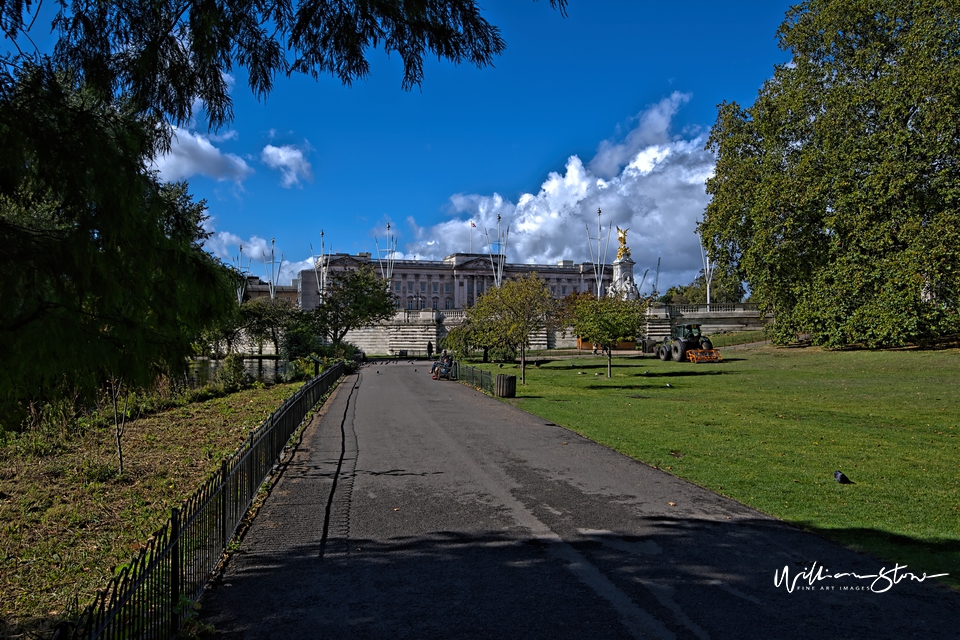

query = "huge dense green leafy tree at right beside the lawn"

[{"left": 700, "top": 0, "right": 960, "bottom": 347}]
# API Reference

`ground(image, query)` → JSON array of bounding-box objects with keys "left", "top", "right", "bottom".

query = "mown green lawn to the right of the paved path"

[{"left": 472, "top": 347, "right": 960, "bottom": 587}]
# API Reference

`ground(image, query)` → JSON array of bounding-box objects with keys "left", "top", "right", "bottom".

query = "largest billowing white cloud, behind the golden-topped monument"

[{"left": 404, "top": 93, "right": 715, "bottom": 293}]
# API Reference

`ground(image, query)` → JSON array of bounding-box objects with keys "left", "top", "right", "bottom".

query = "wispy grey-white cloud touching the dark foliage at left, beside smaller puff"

[{"left": 153, "top": 127, "right": 253, "bottom": 184}]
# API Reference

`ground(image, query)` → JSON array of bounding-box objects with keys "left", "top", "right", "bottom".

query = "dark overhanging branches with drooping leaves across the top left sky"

[{"left": 0, "top": 0, "right": 567, "bottom": 131}]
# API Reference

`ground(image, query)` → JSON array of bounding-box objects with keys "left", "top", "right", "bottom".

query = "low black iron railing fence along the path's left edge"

[{"left": 72, "top": 364, "right": 344, "bottom": 640}]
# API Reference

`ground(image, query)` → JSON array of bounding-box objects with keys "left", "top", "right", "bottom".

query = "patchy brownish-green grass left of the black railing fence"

[{"left": 0, "top": 383, "right": 300, "bottom": 637}]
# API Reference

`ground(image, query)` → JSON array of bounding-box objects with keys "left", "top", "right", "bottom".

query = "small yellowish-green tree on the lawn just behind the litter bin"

[{"left": 467, "top": 273, "right": 558, "bottom": 384}]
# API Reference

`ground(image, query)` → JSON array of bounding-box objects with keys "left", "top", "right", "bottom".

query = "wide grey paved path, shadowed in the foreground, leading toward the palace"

[{"left": 202, "top": 363, "right": 960, "bottom": 639}]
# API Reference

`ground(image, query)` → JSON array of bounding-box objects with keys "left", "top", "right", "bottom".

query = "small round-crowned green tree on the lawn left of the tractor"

[{"left": 573, "top": 296, "right": 647, "bottom": 378}]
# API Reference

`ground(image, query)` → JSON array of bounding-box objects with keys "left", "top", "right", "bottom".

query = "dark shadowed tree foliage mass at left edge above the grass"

[{"left": 0, "top": 70, "right": 236, "bottom": 428}]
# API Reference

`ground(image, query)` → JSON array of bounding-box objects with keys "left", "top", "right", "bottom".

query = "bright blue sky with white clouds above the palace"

[{"left": 142, "top": 0, "right": 790, "bottom": 291}]
